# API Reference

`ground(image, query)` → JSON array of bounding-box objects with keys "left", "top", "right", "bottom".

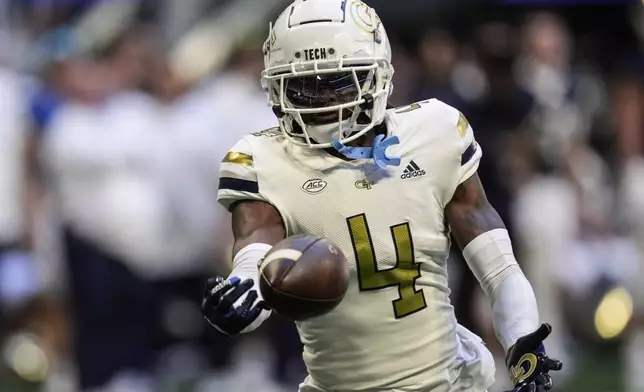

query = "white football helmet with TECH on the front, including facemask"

[{"left": 262, "top": 0, "right": 394, "bottom": 148}]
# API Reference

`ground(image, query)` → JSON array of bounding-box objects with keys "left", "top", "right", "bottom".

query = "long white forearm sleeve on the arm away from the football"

[{"left": 463, "top": 229, "right": 539, "bottom": 352}]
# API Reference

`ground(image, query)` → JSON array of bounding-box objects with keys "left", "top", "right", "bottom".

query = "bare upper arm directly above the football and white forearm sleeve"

[{"left": 231, "top": 201, "right": 286, "bottom": 254}]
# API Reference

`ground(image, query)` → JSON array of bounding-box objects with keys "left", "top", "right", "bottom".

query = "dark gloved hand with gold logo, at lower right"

[{"left": 506, "top": 324, "right": 563, "bottom": 392}]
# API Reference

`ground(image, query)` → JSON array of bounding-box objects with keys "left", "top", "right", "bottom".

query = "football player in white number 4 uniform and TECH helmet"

[{"left": 202, "top": 0, "right": 561, "bottom": 392}]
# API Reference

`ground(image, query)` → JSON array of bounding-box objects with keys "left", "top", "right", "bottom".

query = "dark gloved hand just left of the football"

[{"left": 201, "top": 277, "right": 270, "bottom": 335}]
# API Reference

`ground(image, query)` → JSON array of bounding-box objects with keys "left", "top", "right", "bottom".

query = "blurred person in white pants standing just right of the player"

[{"left": 512, "top": 14, "right": 616, "bottom": 388}]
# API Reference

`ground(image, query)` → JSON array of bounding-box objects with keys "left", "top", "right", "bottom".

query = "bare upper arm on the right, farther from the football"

[{"left": 445, "top": 173, "right": 505, "bottom": 249}]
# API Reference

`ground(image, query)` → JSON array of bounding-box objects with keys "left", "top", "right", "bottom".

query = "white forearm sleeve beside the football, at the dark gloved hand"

[{"left": 229, "top": 243, "right": 272, "bottom": 333}]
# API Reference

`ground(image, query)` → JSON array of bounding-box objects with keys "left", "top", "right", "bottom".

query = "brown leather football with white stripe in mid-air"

[{"left": 259, "top": 235, "right": 349, "bottom": 321}]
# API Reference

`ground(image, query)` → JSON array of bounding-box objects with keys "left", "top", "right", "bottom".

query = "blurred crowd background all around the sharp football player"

[{"left": 0, "top": 0, "right": 644, "bottom": 392}]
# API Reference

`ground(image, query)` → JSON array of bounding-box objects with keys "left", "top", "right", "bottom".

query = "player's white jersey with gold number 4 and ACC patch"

[{"left": 219, "top": 99, "right": 491, "bottom": 391}]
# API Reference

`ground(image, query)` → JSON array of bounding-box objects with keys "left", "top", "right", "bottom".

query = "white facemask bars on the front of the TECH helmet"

[{"left": 262, "top": 58, "right": 393, "bottom": 148}]
